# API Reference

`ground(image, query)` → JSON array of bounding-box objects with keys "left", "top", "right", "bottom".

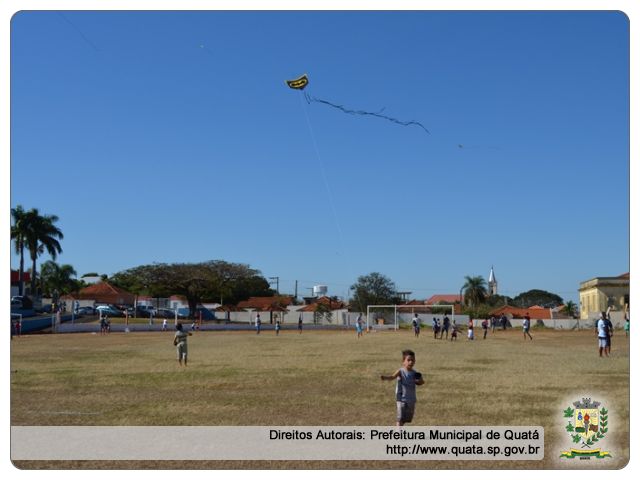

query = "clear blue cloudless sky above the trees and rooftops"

[{"left": 10, "top": 11, "right": 629, "bottom": 301}]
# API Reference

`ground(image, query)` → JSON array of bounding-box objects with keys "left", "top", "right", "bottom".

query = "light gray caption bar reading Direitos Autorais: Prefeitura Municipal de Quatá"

[{"left": 11, "top": 426, "right": 544, "bottom": 460}]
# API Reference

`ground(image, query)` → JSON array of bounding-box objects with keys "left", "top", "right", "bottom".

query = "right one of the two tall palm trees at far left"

[{"left": 24, "top": 208, "right": 64, "bottom": 295}]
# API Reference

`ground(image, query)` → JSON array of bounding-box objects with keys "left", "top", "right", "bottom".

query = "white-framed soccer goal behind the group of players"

[{"left": 367, "top": 304, "right": 455, "bottom": 330}]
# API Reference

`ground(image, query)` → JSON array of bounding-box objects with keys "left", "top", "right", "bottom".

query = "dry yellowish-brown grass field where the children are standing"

[{"left": 11, "top": 329, "right": 629, "bottom": 468}]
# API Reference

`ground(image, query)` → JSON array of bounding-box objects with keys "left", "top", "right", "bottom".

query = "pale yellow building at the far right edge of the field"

[{"left": 578, "top": 272, "right": 629, "bottom": 320}]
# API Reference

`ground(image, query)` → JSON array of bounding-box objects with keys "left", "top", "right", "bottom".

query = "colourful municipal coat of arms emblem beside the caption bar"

[{"left": 560, "top": 398, "right": 611, "bottom": 458}]
